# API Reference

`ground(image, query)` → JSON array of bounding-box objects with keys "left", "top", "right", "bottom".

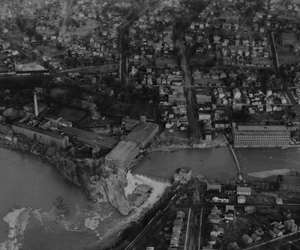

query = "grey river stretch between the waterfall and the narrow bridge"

[{"left": 133, "top": 147, "right": 236, "bottom": 181}]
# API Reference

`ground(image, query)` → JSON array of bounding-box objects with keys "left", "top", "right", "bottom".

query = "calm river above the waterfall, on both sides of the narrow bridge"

[{"left": 133, "top": 147, "right": 300, "bottom": 181}]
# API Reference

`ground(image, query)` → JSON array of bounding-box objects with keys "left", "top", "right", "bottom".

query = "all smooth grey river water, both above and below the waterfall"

[{"left": 0, "top": 147, "right": 300, "bottom": 250}]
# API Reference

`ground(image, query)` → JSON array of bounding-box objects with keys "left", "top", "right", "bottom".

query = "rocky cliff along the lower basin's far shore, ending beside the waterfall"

[{"left": 0, "top": 136, "right": 131, "bottom": 215}]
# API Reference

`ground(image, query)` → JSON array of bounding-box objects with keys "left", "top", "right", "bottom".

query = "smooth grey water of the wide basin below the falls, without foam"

[{"left": 0, "top": 148, "right": 102, "bottom": 250}]
